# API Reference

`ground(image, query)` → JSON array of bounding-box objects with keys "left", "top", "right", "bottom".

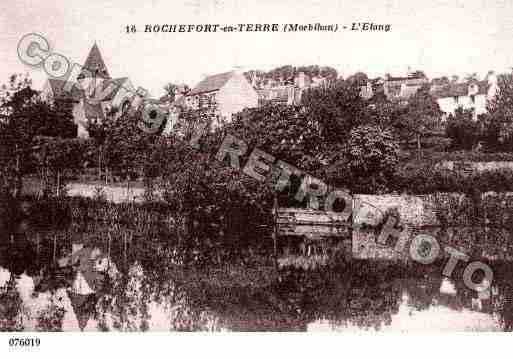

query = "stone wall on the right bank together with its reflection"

[{"left": 352, "top": 193, "right": 513, "bottom": 260}]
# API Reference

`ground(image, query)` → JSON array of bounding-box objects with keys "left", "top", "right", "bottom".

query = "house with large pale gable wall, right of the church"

[{"left": 180, "top": 71, "right": 258, "bottom": 128}]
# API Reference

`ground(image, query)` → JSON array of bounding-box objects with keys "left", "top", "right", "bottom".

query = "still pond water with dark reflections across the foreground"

[{"left": 0, "top": 198, "right": 513, "bottom": 332}]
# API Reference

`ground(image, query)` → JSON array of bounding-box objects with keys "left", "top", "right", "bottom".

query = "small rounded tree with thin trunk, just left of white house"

[{"left": 403, "top": 85, "right": 442, "bottom": 154}]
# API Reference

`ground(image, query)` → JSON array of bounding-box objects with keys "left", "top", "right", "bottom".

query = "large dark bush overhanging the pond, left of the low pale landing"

[{"left": 164, "top": 135, "right": 272, "bottom": 263}]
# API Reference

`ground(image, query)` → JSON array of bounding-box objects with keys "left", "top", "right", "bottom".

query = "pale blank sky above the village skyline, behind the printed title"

[{"left": 0, "top": 0, "right": 513, "bottom": 96}]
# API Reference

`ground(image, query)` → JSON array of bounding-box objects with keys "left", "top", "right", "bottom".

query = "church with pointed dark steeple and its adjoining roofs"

[{"left": 41, "top": 43, "right": 136, "bottom": 138}]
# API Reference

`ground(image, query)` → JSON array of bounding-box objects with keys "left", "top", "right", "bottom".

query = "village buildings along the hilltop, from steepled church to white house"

[{"left": 41, "top": 43, "right": 498, "bottom": 138}]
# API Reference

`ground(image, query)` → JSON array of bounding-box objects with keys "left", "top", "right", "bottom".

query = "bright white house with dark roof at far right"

[{"left": 431, "top": 72, "right": 498, "bottom": 120}]
